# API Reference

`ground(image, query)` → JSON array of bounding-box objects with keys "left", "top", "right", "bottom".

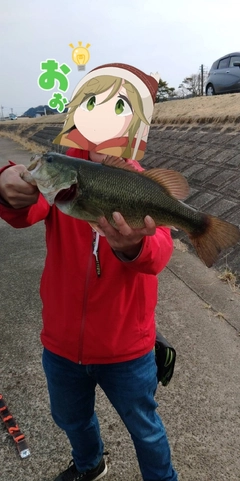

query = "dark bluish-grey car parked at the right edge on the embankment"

[{"left": 205, "top": 52, "right": 240, "bottom": 95}]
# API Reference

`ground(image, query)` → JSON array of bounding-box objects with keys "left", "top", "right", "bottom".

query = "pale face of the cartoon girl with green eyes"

[{"left": 73, "top": 80, "right": 134, "bottom": 145}]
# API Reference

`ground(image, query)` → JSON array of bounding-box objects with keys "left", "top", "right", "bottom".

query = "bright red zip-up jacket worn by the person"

[{"left": 0, "top": 149, "right": 173, "bottom": 364}]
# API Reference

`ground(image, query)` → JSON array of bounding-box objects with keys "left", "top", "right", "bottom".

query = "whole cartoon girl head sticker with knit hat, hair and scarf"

[{"left": 54, "top": 64, "right": 158, "bottom": 160}]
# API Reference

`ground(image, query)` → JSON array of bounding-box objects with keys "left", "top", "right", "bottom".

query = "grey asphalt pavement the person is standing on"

[{"left": 0, "top": 138, "right": 240, "bottom": 481}]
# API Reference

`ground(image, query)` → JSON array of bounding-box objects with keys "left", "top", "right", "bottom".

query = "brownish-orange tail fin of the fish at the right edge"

[{"left": 188, "top": 215, "right": 240, "bottom": 267}]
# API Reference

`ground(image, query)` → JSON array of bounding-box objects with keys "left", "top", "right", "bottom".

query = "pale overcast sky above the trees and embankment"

[{"left": 0, "top": 0, "right": 240, "bottom": 115}]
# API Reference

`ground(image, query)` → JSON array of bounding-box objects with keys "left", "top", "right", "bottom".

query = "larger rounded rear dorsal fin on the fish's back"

[{"left": 141, "top": 169, "right": 189, "bottom": 200}]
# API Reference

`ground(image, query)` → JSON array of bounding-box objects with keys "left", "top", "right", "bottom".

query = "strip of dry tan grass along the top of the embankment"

[{"left": 0, "top": 93, "right": 240, "bottom": 152}]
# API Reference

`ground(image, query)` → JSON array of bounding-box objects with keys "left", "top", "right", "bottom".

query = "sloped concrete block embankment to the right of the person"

[{"left": 142, "top": 125, "right": 240, "bottom": 280}]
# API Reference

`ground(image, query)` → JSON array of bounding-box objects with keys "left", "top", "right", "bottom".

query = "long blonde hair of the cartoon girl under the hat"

[{"left": 54, "top": 75, "right": 150, "bottom": 157}]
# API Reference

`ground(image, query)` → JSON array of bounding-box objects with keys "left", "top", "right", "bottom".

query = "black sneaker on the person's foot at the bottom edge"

[{"left": 54, "top": 458, "right": 107, "bottom": 481}]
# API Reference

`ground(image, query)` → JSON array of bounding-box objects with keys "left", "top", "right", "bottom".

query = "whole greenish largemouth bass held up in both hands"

[{"left": 22, "top": 152, "right": 240, "bottom": 267}]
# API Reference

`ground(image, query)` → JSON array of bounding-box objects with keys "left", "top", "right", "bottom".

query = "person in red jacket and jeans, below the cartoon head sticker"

[{"left": 0, "top": 62, "right": 177, "bottom": 481}]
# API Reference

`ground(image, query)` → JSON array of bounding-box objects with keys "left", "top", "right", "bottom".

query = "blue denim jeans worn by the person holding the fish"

[{"left": 43, "top": 349, "right": 177, "bottom": 481}]
